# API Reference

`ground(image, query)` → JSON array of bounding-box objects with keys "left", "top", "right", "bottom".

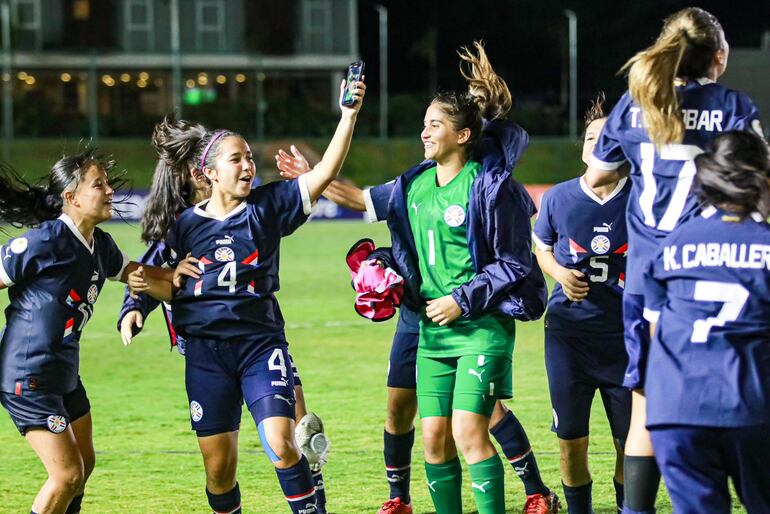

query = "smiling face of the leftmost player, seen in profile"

[{"left": 63, "top": 163, "right": 113, "bottom": 225}]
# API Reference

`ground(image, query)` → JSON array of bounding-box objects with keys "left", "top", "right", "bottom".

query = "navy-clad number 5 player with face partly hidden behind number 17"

[{"left": 532, "top": 94, "right": 631, "bottom": 508}]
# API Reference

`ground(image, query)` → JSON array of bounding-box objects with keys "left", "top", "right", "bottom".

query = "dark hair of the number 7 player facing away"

[{"left": 693, "top": 130, "right": 770, "bottom": 219}]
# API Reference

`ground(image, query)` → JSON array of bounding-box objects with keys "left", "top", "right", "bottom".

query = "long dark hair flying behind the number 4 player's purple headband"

[{"left": 142, "top": 114, "right": 238, "bottom": 243}]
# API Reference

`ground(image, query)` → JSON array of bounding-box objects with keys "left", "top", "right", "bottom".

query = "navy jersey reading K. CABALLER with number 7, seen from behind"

[{"left": 645, "top": 208, "right": 770, "bottom": 427}]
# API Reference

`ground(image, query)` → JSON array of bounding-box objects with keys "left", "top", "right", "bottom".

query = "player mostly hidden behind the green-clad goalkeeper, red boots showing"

[{"left": 276, "top": 43, "right": 559, "bottom": 514}]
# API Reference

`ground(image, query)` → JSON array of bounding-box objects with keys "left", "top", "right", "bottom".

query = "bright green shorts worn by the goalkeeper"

[{"left": 417, "top": 352, "right": 513, "bottom": 418}]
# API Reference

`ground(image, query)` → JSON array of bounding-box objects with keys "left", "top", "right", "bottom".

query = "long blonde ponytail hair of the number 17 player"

[{"left": 620, "top": 7, "right": 726, "bottom": 147}]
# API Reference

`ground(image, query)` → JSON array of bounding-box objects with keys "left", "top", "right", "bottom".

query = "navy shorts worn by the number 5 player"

[{"left": 545, "top": 330, "right": 631, "bottom": 440}]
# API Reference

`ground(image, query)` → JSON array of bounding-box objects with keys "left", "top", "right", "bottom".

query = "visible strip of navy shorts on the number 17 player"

[{"left": 623, "top": 293, "right": 650, "bottom": 389}]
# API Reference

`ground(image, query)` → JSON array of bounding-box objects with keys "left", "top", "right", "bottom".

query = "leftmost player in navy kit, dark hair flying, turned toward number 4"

[{"left": 0, "top": 148, "right": 176, "bottom": 508}]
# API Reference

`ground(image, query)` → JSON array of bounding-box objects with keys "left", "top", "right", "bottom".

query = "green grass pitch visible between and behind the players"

[{"left": 0, "top": 222, "right": 736, "bottom": 514}]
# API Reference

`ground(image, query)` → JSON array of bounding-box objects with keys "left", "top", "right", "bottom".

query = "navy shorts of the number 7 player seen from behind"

[{"left": 650, "top": 424, "right": 770, "bottom": 514}]
